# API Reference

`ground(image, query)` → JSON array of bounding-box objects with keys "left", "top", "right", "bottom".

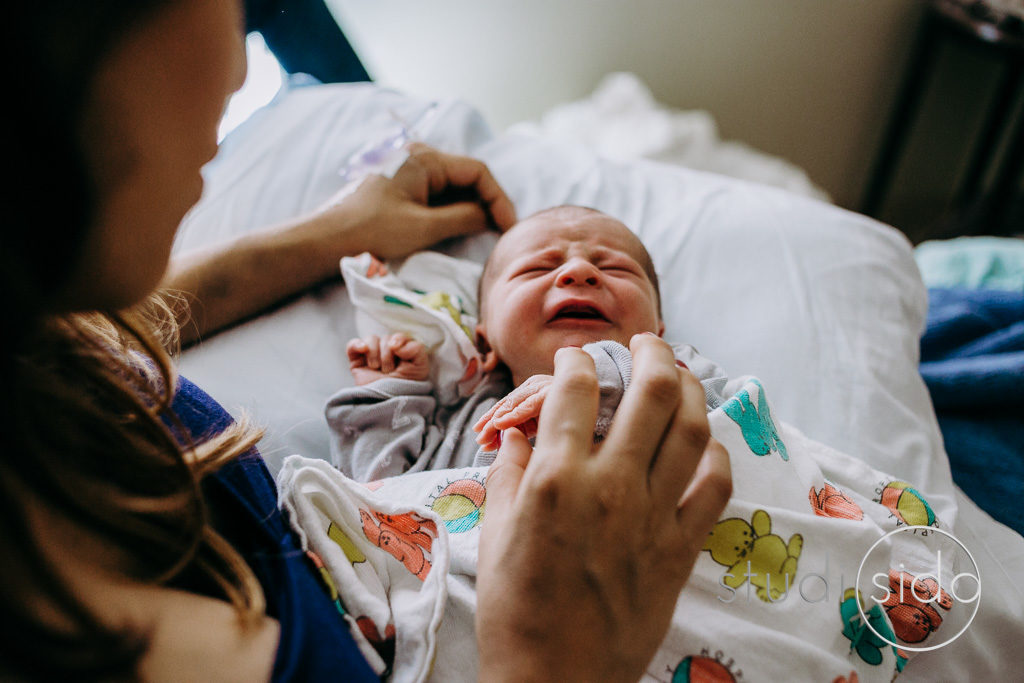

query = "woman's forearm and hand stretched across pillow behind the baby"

[{"left": 163, "top": 144, "right": 515, "bottom": 344}]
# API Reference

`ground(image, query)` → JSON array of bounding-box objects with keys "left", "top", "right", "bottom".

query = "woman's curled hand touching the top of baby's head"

[{"left": 313, "top": 142, "right": 516, "bottom": 261}]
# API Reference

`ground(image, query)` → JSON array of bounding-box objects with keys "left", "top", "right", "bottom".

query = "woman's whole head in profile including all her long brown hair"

[{"left": 0, "top": 0, "right": 256, "bottom": 678}]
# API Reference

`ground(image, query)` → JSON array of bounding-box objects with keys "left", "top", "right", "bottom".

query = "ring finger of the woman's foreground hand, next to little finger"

[{"left": 647, "top": 369, "right": 711, "bottom": 506}]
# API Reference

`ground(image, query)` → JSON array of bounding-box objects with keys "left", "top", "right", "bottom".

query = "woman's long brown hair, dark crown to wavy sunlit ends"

[{"left": 0, "top": 0, "right": 264, "bottom": 680}]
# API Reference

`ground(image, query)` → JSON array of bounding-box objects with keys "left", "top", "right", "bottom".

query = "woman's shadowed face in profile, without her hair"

[{"left": 71, "top": 0, "right": 245, "bottom": 308}]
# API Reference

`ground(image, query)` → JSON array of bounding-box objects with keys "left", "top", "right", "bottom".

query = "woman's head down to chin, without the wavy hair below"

[{"left": 9, "top": 0, "right": 245, "bottom": 321}]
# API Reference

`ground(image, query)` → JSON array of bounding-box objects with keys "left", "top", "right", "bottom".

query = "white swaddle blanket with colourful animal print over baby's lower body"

[{"left": 279, "top": 378, "right": 958, "bottom": 681}]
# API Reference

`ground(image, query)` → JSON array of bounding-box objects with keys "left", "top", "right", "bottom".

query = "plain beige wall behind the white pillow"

[{"left": 329, "top": 0, "right": 974, "bottom": 216}]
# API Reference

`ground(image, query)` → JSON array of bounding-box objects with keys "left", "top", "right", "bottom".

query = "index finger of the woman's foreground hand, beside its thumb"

[{"left": 537, "top": 347, "right": 600, "bottom": 460}]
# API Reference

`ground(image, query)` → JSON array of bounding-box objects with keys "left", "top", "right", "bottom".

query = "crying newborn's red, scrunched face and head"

[{"left": 477, "top": 207, "right": 665, "bottom": 386}]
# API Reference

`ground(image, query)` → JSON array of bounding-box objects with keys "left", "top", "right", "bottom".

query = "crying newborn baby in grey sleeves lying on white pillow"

[{"left": 327, "top": 206, "right": 725, "bottom": 481}]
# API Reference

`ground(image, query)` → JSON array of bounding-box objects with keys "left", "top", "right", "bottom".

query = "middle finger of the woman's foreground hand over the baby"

[{"left": 598, "top": 334, "right": 684, "bottom": 476}]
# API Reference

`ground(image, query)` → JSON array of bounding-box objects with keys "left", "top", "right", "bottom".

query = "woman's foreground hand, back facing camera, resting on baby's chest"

[{"left": 476, "top": 335, "right": 732, "bottom": 681}]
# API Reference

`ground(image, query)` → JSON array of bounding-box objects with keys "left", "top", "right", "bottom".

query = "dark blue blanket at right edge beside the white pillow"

[{"left": 921, "top": 289, "right": 1024, "bottom": 533}]
